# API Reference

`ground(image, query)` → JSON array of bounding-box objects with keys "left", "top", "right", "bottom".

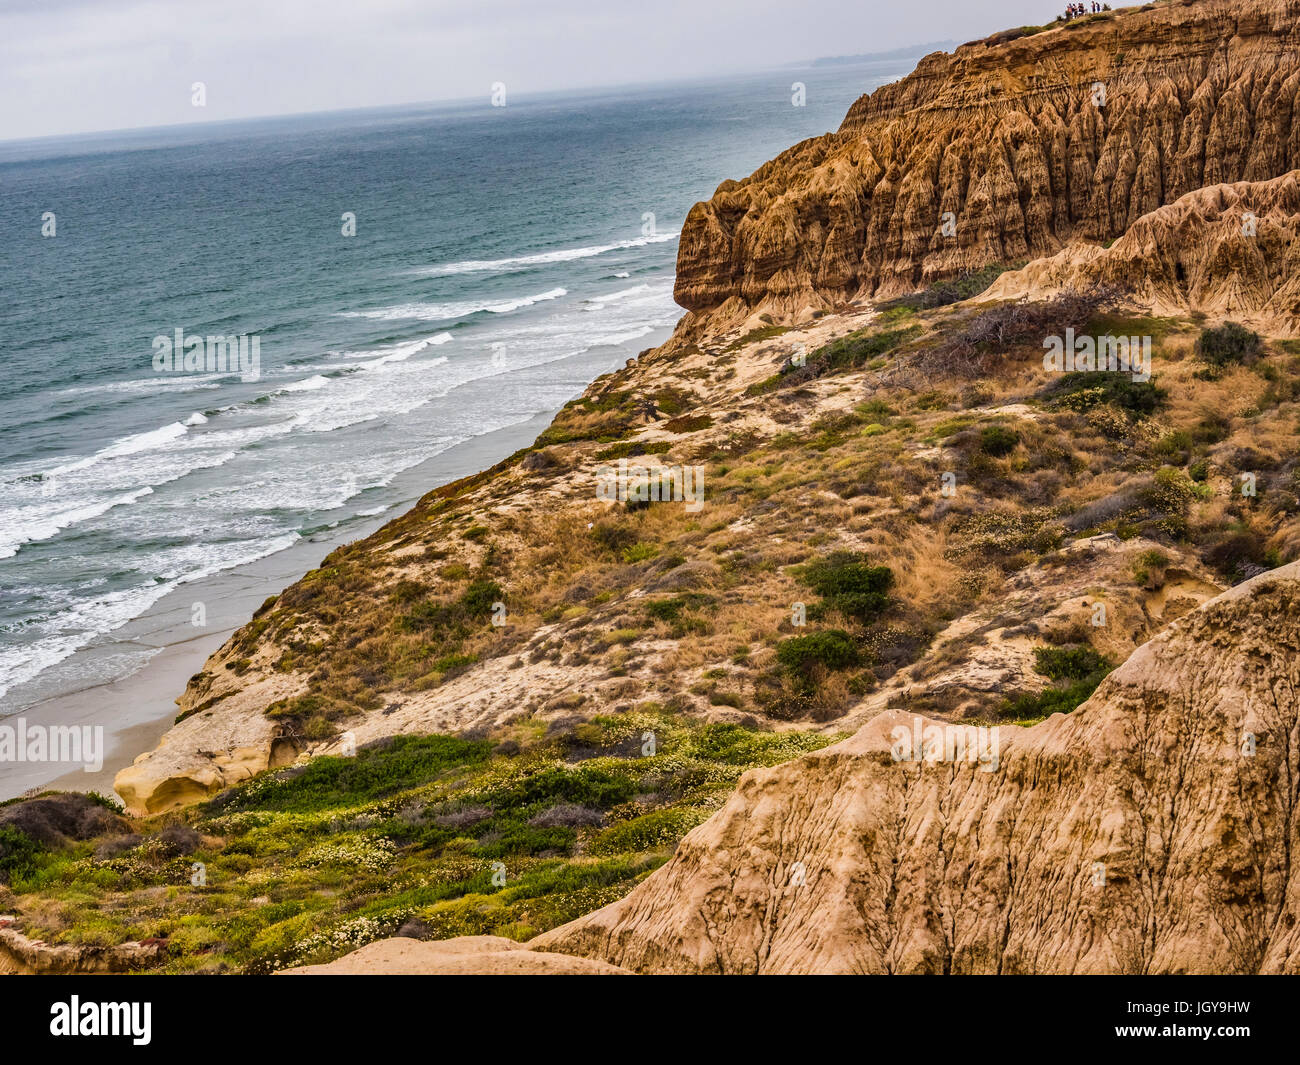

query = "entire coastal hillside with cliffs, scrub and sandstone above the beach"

[{"left": 0, "top": 0, "right": 1300, "bottom": 973}]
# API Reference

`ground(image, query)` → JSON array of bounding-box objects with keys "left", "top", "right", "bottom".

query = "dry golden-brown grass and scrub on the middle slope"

[{"left": 190, "top": 294, "right": 1300, "bottom": 722}]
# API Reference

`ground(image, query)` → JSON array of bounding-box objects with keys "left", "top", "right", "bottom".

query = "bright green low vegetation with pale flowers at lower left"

[{"left": 0, "top": 703, "right": 833, "bottom": 973}]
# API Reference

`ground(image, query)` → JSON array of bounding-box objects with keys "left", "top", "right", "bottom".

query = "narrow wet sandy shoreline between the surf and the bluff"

[{"left": 0, "top": 326, "right": 672, "bottom": 801}]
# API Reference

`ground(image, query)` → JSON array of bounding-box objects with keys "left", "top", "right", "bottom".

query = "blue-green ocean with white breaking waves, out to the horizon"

[{"left": 0, "top": 60, "right": 914, "bottom": 714}]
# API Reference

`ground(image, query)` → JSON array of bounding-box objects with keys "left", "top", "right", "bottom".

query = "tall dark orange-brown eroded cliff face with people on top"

[{"left": 675, "top": 0, "right": 1300, "bottom": 330}]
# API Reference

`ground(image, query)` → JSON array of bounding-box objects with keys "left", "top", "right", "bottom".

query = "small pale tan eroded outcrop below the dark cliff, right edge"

[{"left": 985, "top": 170, "right": 1300, "bottom": 335}]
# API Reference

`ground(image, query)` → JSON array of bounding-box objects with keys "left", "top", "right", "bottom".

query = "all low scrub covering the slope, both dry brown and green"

[{"left": 61, "top": 280, "right": 1300, "bottom": 971}]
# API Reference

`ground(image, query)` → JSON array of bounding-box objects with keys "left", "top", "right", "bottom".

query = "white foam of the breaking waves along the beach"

[{"left": 0, "top": 262, "right": 680, "bottom": 694}]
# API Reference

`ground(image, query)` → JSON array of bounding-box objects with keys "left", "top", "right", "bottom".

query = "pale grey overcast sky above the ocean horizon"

[{"left": 0, "top": 0, "right": 1045, "bottom": 139}]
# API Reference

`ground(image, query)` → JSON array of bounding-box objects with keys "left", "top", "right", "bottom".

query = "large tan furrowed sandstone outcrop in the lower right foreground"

[{"left": 530, "top": 563, "right": 1300, "bottom": 973}]
